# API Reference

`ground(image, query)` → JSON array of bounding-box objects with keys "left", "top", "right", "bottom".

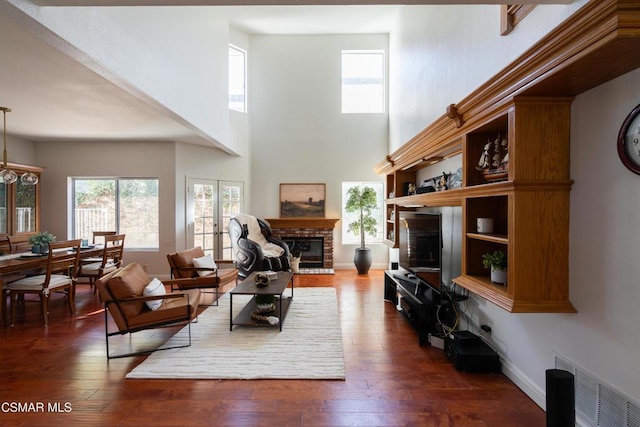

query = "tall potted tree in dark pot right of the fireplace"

[{"left": 345, "top": 187, "right": 378, "bottom": 274}]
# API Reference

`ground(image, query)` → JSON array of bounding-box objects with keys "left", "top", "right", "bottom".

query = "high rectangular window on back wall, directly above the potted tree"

[{"left": 342, "top": 50, "right": 385, "bottom": 113}]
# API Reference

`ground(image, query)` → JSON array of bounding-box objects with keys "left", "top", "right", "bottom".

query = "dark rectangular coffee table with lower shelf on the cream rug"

[{"left": 229, "top": 271, "right": 294, "bottom": 331}]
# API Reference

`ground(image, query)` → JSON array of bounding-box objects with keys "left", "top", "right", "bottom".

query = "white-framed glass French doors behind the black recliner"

[{"left": 187, "top": 178, "right": 244, "bottom": 259}]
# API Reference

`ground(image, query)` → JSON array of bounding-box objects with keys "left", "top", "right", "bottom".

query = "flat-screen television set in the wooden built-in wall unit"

[{"left": 398, "top": 212, "right": 442, "bottom": 293}]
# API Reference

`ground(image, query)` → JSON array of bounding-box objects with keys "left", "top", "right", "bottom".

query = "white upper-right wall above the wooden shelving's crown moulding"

[{"left": 390, "top": 0, "right": 586, "bottom": 152}]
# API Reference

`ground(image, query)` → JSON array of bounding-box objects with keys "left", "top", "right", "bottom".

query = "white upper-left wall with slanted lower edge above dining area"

[{"left": 13, "top": 0, "right": 239, "bottom": 153}]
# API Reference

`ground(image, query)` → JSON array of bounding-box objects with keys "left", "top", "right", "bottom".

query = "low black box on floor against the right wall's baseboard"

[{"left": 444, "top": 336, "right": 500, "bottom": 372}]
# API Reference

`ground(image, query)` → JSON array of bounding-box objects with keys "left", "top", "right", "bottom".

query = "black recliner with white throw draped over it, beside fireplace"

[{"left": 229, "top": 214, "right": 290, "bottom": 277}]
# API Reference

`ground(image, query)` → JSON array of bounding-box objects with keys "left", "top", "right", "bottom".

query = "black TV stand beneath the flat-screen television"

[{"left": 384, "top": 270, "right": 449, "bottom": 345}]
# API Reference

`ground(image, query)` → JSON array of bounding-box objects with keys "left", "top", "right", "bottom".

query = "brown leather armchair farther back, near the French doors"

[{"left": 165, "top": 246, "right": 238, "bottom": 305}]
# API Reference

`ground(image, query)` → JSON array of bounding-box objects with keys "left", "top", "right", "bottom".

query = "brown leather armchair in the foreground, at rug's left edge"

[{"left": 96, "top": 263, "right": 200, "bottom": 359}]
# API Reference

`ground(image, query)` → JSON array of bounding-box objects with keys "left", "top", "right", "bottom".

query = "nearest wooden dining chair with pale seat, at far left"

[{"left": 7, "top": 239, "right": 81, "bottom": 326}]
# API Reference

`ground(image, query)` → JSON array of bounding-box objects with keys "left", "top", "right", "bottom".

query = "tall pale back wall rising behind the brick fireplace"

[{"left": 249, "top": 35, "right": 388, "bottom": 269}]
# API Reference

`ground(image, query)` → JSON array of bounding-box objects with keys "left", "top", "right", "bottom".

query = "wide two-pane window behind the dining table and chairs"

[{"left": 73, "top": 178, "right": 160, "bottom": 249}]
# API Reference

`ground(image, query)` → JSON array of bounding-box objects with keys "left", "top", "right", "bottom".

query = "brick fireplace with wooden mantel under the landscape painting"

[{"left": 266, "top": 218, "right": 339, "bottom": 269}]
